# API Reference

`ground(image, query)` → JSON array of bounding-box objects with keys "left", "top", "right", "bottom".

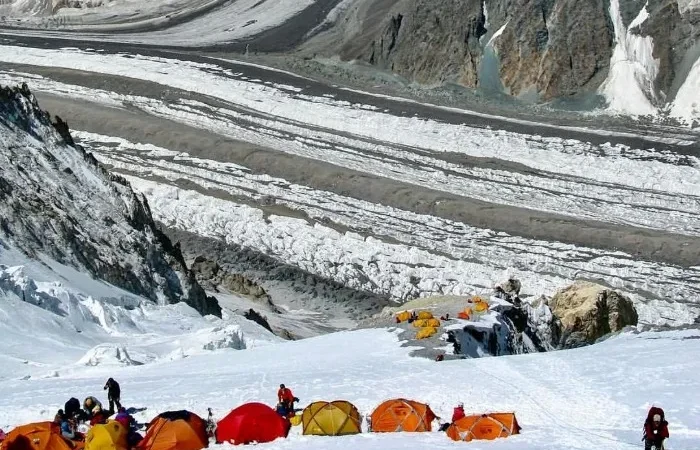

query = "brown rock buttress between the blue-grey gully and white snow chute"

[{"left": 487, "top": 0, "right": 613, "bottom": 100}]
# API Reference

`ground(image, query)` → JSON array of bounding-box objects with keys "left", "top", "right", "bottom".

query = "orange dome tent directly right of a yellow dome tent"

[{"left": 371, "top": 398, "right": 435, "bottom": 432}]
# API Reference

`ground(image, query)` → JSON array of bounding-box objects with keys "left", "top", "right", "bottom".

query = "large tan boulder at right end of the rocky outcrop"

[{"left": 549, "top": 281, "right": 638, "bottom": 348}]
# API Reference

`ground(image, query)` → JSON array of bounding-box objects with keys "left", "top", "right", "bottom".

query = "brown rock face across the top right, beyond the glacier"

[{"left": 306, "top": 0, "right": 700, "bottom": 107}]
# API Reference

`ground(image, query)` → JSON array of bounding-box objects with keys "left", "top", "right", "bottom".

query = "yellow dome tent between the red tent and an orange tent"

[{"left": 301, "top": 400, "right": 362, "bottom": 436}]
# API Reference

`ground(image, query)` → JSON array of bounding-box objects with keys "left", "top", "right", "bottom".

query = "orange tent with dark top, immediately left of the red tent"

[{"left": 136, "top": 411, "right": 209, "bottom": 450}]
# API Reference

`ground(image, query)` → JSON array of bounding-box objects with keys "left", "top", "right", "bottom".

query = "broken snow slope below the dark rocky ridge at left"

[{"left": 0, "top": 241, "right": 280, "bottom": 382}]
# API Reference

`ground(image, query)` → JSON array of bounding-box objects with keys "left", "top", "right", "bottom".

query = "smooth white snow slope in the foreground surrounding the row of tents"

[{"left": 0, "top": 329, "right": 700, "bottom": 450}]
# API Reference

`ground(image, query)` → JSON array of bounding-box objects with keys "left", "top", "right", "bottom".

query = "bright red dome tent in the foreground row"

[{"left": 216, "top": 403, "right": 291, "bottom": 444}]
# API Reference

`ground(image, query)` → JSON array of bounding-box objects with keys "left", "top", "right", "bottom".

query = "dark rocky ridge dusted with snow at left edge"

[{"left": 0, "top": 85, "right": 221, "bottom": 315}]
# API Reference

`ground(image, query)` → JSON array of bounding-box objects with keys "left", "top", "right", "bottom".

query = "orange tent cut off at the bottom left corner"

[{"left": 0, "top": 422, "right": 84, "bottom": 450}]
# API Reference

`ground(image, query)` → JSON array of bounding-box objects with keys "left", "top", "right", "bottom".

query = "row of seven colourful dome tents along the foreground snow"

[{"left": 0, "top": 398, "right": 520, "bottom": 450}]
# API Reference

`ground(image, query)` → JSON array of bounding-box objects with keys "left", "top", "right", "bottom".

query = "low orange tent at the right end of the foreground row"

[{"left": 447, "top": 413, "right": 520, "bottom": 441}]
